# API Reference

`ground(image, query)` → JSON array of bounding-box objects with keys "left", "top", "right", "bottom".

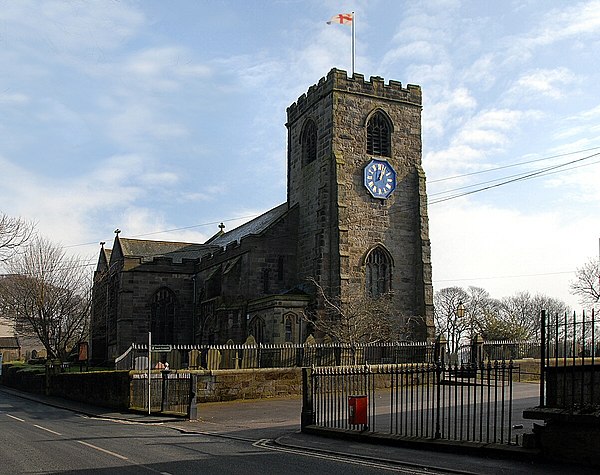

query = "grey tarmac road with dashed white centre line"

[{"left": 0, "top": 392, "right": 464, "bottom": 475}]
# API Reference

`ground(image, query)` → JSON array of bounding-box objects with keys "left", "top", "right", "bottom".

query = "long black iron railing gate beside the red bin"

[{"left": 302, "top": 361, "right": 518, "bottom": 445}]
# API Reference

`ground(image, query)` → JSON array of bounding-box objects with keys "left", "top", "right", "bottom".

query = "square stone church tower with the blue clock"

[{"left": 286, "top": 69, "right": 433, "bottom": 339}]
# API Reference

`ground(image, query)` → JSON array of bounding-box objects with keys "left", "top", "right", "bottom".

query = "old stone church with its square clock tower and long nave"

[{"left": 91, "top": 69, "right": 433, "bottom": 361}]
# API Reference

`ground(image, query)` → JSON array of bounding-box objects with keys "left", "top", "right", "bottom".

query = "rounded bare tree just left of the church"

[{"left": 0, "top": 237, "right": 91, "bottom": 359}]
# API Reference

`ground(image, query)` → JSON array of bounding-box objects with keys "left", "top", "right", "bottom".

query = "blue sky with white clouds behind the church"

[{"left": 0, "top": 0, "right": 600, "bottom": 309}]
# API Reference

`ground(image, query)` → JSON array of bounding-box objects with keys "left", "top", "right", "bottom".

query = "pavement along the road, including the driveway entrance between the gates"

[{"left": 0, "top": 386, "right": 589, "bottom": 475}]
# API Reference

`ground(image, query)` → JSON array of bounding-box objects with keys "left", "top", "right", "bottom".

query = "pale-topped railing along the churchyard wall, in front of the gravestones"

[{"left": 115, "top": 342, "right": 435, "bottom": 370}]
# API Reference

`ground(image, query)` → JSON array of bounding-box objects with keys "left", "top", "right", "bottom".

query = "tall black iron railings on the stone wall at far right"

[{"left": 540, "top": 310, "right": 600, "bottom": 410}]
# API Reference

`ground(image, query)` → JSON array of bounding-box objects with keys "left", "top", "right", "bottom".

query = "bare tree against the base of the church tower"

[{"left": 304, "top": 279, "right": 411, "bottom": 347}]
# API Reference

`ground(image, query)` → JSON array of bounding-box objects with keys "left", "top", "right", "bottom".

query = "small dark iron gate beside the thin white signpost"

[{"left": 130, "top": 371, "right": 196, "bottom": 416}]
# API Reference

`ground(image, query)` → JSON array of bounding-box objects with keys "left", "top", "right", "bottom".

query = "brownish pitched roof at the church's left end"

[{"left": 119, "top": 238, "right": 218, "bottom": 262}]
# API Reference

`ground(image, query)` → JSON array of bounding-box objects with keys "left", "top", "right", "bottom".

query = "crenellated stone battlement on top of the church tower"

[{"left": 287, "top": 68, "right": 422, "bottom": 123}]
